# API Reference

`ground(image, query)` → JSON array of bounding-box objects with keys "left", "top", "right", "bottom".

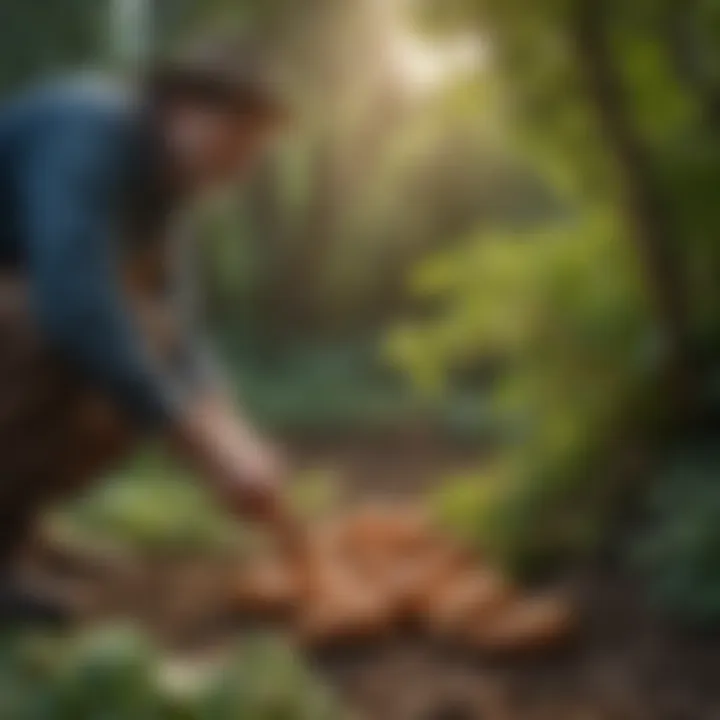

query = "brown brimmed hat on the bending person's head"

[{"left": 145, "top": 38, "right": 287, "bottom": 120}]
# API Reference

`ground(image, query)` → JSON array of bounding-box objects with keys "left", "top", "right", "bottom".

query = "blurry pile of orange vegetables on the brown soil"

[{"left": 234, "top": 506, "right": 576, "bottom": 653}]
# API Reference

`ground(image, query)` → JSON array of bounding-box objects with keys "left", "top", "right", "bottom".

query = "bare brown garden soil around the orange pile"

[{"left": 21, "top": 443, "right": 720, "bottom": 720}]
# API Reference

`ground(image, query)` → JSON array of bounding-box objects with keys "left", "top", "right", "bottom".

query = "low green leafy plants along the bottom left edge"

[{"left": 0, "top": 626, "right": 344, "bottom": 720}]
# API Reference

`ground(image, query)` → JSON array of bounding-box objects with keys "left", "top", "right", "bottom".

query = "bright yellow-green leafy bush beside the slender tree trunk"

[{"left": 388, "top": 211, "right": 659, "bottom": 568}]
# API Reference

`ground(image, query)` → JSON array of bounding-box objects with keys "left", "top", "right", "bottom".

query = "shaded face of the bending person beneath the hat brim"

[{"left": 170, "top": 107, "right": 277, "bottom": 194}]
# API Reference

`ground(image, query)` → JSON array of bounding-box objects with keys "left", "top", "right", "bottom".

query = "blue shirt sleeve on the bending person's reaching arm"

[{"left": 24, "top": 109, "right": 176, "bottom": 430}]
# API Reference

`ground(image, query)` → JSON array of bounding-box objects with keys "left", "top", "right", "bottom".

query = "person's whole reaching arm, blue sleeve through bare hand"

[{"left": 22, "top": 108, "right": 288, "bottom": 520}]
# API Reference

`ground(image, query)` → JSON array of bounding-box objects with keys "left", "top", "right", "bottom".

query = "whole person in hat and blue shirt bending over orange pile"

[{"left": 0, "top": 39, "right": 288, "bottom": 620}]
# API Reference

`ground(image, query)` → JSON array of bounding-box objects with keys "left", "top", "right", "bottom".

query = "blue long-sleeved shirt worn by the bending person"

[{"left": 0, "top": 80, "right": 214, "bottom": 430}]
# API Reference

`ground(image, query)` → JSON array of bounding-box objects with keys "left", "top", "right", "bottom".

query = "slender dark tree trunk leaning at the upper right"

[{"left": 571, "top": 0, "right": 696, "bottom": 406}]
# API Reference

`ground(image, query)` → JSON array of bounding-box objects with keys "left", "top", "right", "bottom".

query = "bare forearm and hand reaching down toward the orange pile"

[{"left": 173, "top": 400, "right": 292, "bottom": 532}]
